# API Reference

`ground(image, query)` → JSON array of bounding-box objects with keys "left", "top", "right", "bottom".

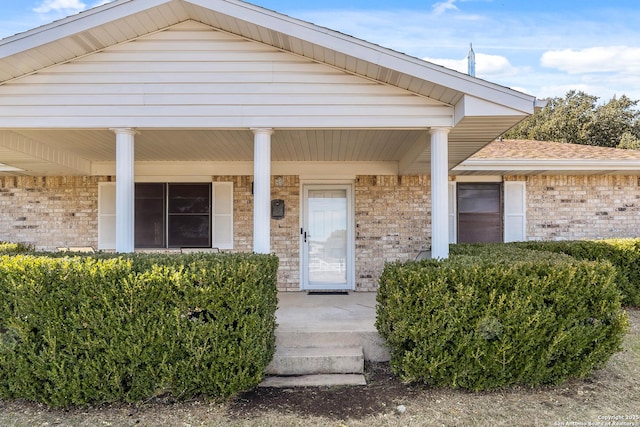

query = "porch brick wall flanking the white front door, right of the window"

[{"left": 214, "top": 176, "right": 431, "bottom": 291}]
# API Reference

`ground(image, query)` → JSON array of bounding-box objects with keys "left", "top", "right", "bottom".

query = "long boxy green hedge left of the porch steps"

[{"left": 0, "top": 254, "right": 278, "bottom": 406}]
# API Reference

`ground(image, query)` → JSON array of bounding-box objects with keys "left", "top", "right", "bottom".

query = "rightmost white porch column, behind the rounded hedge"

[{"left": 430, "top": 128, "right": 449, "bottom": 259}]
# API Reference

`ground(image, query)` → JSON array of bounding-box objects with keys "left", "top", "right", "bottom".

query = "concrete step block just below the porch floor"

[{"left": 266, "top": 346, "right": 364, "bottom": 376}]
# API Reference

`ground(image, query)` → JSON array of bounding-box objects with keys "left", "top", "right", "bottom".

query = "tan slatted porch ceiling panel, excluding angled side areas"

[{"left": 8, "top": 129, "right": 425, "bottom": 162}]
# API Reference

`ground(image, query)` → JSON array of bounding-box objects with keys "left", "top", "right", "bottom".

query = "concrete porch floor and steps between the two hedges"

[{"left": 261, "top": 292, "right": 389, "bottom": 387}]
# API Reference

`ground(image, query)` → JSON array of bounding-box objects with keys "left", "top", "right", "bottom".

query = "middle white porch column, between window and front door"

[{"left": 251, "top": 129, "right": 273, "bottom": 254}]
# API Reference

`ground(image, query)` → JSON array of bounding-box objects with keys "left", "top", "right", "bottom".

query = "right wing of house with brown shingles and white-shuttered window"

[{"left": 449, "top": 140, "right": 640, "bottom": 242}]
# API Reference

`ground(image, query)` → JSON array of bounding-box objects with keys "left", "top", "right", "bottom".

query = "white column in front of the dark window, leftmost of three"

[{"left": 111, "top": 128, "right": 136, "bottom": 252}]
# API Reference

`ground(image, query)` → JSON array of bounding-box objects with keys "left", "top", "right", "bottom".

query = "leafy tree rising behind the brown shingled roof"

[{"left": 504, "top": 91, "right": 640, "bottom": 148}]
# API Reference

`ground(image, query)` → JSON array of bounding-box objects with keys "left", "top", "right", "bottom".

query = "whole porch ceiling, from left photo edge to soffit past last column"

[{"left": 0, "top": 129, "right": 476, "bottom": 176}]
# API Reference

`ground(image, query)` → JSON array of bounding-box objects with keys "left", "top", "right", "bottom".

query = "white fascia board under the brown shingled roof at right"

[{"left": 453, "top": 159, "right": 640, "bottom": 172}]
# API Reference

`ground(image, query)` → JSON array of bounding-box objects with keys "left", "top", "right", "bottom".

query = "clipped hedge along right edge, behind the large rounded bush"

[{"left": 510, "top": 239, "right": 640, "bottom": 307}]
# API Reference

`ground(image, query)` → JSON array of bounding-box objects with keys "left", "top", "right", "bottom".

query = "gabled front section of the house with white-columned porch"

[{"left": 0, "top": 0, "right": 540, "bottom": 290}]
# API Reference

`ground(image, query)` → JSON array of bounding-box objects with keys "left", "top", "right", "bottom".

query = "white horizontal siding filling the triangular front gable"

[{"left": 0, "top": 21, "right": 453, "bottom": 128}]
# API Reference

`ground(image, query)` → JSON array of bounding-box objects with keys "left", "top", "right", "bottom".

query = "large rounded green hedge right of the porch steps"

[{"left": 376, "top": 249, "right": 628, "bottom": 390}]
